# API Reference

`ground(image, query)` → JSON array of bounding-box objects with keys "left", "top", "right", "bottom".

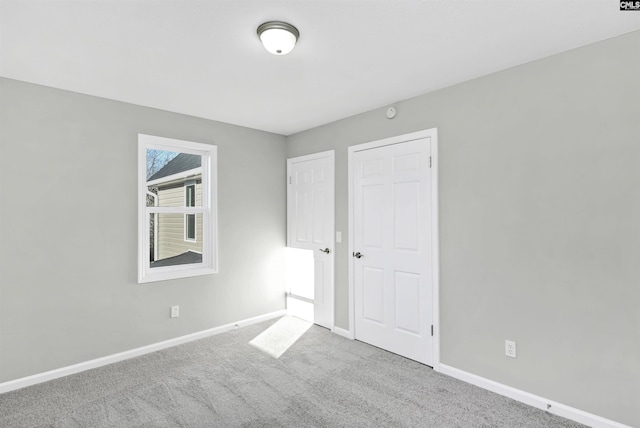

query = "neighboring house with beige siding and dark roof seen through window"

[{"left": 147, "top": 153, "right": 202, "bottom": 267}]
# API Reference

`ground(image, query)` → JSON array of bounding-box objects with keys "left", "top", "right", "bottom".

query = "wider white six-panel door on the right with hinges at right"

[{"left": 351, "top": 137, "right": 433, "bottom": 365}]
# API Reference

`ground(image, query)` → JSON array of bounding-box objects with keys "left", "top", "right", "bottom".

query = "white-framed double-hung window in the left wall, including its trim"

[{"left": 138, "top": 134, "right": 217, "bottom": 283}]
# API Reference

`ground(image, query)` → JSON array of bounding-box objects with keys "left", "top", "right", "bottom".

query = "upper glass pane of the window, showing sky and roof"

[{"left": 147, "top": 149, "right": 202, "bottom": 207}]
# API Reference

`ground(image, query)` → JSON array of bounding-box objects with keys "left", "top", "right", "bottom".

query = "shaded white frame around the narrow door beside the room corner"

[{"left": 287, "top": 150, "right": 336, "bottom": 331}]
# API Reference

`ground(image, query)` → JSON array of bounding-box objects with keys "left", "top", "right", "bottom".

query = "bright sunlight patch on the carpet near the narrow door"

[{"left": 249, "top": 316, "right": 313, "bottom": 358}]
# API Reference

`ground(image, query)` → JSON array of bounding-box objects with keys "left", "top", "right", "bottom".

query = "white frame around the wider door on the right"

[{"left": 348, "top": 128, "right": 440, "bottom": 371}]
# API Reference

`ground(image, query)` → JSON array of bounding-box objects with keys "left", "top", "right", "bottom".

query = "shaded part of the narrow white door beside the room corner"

[{"left": 287, "top": 151, "right": 335, "bottom": 329}]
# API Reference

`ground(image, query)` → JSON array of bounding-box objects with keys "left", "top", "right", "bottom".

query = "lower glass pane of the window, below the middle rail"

[{"left": 149, "top": 213, "right": 202, "bottom": 268}]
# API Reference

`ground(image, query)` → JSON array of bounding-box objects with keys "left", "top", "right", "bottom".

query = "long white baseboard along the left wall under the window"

[{"left": 0, "top": 309, "right": 286, "bottom": 394}]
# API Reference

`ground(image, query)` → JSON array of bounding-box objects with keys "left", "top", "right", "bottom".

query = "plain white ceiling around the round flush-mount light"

[{"left": 0, "top": 0, "right": 640, "bottom": 135}]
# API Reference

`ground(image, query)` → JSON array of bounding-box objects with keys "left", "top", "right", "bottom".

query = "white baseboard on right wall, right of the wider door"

[{"left": 440, "top": 364, "right": 631, "bottom": 428}]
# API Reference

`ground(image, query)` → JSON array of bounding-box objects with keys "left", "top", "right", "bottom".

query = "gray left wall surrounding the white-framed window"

[{"left": 0, "top": 79, "right": 286, "bottom": 382}]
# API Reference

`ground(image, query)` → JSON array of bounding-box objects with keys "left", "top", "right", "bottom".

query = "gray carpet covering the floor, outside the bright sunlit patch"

[{"left": 0, "top": 321, "right": 583, "bottom": 428}]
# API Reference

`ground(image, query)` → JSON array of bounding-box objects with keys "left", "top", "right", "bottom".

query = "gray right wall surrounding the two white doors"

[{"left": 287, "top": 32, "right": 640, "bottom": 426}]
